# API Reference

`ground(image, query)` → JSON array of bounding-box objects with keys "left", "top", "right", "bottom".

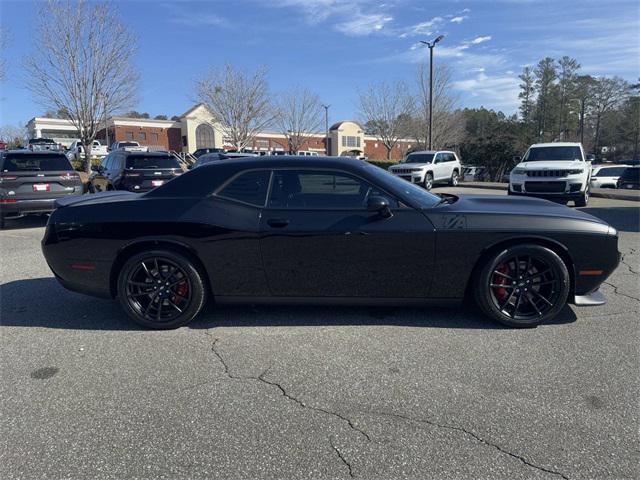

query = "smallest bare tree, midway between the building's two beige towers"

[{"left": 276, "top": 87, "right": 324, "bottom": 153}]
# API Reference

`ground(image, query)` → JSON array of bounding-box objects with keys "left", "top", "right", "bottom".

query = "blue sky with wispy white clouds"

[{"left": 0, "top": 0, "right": 640, "bottom": 125}]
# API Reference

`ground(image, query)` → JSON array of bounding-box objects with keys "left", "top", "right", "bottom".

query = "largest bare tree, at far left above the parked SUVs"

[{"left": 25, "top": 0, "right": 138, "bottom": 171}]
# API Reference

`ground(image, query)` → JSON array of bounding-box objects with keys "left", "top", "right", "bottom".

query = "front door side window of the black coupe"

[{"left": 269, "top": 170, "right": 398, "bottom": 210}]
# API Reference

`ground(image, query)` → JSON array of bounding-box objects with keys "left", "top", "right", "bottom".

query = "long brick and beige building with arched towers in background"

[{"left": 27, "top": 104, "right": 415, "bottom": 160}]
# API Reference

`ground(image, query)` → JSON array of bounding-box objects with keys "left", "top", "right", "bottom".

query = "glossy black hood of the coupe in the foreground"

[{"left": 425, "top": 195, "right": 611, "bottom": 234}]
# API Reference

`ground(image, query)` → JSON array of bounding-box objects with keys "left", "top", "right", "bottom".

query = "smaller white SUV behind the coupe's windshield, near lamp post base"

[{"left": 389, "top": 150, "right": 462, "bottom": 190}]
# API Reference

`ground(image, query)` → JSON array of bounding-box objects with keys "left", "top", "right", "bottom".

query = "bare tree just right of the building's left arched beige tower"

[{"left": 195, "top": 64, "right": 275, "bottom": 151}]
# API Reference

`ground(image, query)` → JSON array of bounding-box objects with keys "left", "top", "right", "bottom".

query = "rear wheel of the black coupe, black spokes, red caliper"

[{"left": 118, "top": 250, "right": 207, "bottom": 329}]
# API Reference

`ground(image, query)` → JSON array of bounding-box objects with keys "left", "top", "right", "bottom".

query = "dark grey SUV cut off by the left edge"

[{"left": 0, "top": 150, "right": 82, "bottom": 228}]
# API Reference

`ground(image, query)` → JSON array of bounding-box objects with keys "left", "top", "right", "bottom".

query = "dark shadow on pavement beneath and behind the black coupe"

[{"left": 0, "top": 277, "right": 576, "bottom": 331}]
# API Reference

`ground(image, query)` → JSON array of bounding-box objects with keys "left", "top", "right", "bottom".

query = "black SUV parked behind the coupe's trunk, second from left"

[{"left": 89, "top": 150, "right": 183, "bottom": 193}]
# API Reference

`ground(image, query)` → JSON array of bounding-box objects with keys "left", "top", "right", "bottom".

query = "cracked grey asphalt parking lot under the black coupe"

[{"left": 0, "top": 188, "right": 640, "bottom": 479}]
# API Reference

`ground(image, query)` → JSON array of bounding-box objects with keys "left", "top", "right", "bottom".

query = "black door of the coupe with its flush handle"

[{"left": 260, "top": 172, "right": 435, "bottom": 298}]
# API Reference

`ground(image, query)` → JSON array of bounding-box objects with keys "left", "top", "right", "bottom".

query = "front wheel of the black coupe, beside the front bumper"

[{"left": 473, "top": 244, "right": 570, "bottom": 328}]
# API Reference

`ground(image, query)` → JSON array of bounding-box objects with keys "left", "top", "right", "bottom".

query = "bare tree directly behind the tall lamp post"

[{"left": 410, "top": 63, "right": 465, "bottom": 148}]
